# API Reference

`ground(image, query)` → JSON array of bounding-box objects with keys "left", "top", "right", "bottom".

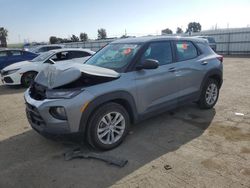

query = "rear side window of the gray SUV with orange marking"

[{"left": 176, "top": 41, "right": 198, "bottom": 61}]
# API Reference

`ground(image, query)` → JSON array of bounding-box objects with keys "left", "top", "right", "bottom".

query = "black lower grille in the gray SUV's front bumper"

[{"left": 26, "top": 103, "right": 45, "bottom": 126}]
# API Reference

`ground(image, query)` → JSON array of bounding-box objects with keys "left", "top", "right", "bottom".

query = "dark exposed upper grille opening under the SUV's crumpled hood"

[{"left": 30, "top": 82, "right": 47, "bottom": 100}]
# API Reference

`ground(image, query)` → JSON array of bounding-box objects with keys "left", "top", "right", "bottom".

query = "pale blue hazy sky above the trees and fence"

[{"left": 0, "top": 0, "right": 250, "bottom": 43}]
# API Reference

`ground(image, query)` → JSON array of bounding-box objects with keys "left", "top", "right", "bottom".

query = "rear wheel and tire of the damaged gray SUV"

[{"left": 198, "top": 78, "right": 220, "bottom": 109}]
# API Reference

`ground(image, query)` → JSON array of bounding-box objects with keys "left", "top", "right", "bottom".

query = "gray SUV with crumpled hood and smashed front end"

[{"left": 25, "top": 37, "right": 223, "bottom": 150}]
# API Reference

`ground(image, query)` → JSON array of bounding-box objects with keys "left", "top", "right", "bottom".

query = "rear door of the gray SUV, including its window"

[{"left": 174, "top": 41, "right": 205, "bottom": 101}]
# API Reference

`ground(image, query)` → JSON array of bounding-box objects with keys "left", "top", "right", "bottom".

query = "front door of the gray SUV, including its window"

[{"left": 136, "top": 41, "right": 178, "bottom": 113}]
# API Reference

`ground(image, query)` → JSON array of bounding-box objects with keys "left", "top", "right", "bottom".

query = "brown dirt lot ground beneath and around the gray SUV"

[{"left": 0, "top": 58, "right": 250, "bottom": 188}]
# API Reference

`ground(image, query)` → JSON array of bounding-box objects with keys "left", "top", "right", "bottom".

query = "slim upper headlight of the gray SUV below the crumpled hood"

[{"left": 46, "top": 89, "right": 83, "bottom": 99}]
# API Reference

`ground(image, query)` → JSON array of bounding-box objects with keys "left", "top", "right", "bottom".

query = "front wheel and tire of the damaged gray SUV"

[{"left": 87, "top": 103, "right": 130, "bottom": 150}]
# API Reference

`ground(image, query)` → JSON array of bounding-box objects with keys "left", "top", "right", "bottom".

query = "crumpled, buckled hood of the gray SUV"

[{"left": 35, "top": 63, "right": 120, "bottom": 89}]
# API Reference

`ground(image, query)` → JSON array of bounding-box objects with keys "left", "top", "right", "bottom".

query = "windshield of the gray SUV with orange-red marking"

[{"left": 86, "top": 44, "right": 141, "bottom": 70}]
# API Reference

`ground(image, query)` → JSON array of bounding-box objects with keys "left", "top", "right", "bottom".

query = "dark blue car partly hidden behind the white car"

[{"left": 0, "top": 49, "right": 38, "bottom": 70}]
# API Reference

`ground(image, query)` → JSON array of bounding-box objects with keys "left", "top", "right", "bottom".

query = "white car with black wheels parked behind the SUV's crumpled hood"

[{"left": 1, "top": 48, "right": 95, "bottom": 87}]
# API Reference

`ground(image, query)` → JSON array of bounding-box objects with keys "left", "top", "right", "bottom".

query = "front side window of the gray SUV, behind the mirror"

[{"left": 141, "top": 42, "right": 173, "bottom": 65}]
